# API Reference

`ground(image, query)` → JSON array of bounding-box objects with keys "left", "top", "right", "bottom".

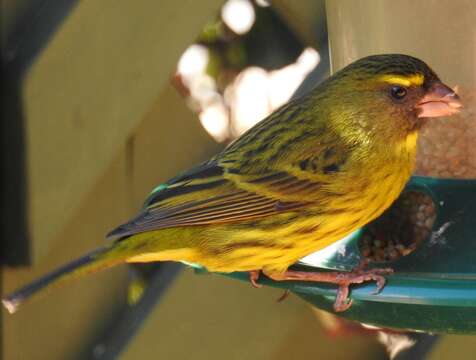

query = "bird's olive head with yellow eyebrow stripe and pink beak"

[{"left": 323, "top": 54, "right": 462, "bottom": 141}]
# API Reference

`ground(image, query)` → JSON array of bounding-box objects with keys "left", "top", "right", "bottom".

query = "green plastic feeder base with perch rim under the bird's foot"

[{"left": 225, "top": 176, "right": 476, "bottom": 334}]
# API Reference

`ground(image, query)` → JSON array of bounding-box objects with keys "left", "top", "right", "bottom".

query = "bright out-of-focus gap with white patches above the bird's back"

[{"left": 174, "top": 0, "right": 319, "bottom": 141}]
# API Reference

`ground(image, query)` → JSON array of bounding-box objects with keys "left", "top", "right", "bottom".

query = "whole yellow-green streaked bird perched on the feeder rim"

[{"left": 2, "top": 54, "right": 462, "bottom": 312}]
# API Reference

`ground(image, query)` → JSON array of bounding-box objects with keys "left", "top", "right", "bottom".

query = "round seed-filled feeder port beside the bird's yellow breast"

[{"left": 359, "top": 191, "right": 436, "bottom": 262}]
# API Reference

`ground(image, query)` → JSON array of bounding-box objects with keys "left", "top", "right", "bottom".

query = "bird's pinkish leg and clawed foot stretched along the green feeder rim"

[{"left": 265, "top": 266, "right": 393, "bottom": 312}]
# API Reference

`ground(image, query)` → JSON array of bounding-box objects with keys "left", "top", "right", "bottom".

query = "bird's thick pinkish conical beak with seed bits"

[{"left": 416, "top": 82, "right": 463, "bottom": 118}]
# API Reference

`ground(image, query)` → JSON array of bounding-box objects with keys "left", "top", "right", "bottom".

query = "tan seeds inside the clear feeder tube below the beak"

[{"left": 415, "top": 89, "right": 476, "bottom": 179}]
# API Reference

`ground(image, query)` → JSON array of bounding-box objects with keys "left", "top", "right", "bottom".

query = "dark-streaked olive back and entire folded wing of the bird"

[{"left": 108, "top": 100, "right": 346, "bottom": 238}]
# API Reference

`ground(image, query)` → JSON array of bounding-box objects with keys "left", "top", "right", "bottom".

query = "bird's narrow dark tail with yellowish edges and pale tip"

[{"left": 2, "top": 246, "right": 124, "bottom": 313}]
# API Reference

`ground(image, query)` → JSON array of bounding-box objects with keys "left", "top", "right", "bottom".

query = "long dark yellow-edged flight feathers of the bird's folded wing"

[{"left": 108, "top": 160, "right": 311, "bottom": 239}]
